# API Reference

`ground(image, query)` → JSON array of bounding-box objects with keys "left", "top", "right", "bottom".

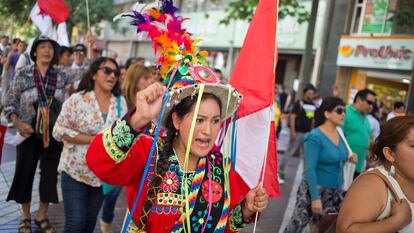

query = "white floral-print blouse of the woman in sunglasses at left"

[{"left": 53, "top": 91, "right": 127, "bottom": 187}]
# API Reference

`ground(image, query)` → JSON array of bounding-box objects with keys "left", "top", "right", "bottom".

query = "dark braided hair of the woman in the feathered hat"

[{"left": 140, "top": 93, "right": 222, "bottom": 227}]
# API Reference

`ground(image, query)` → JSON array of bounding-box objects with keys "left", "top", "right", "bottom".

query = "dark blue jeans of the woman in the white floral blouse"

[{"left": 61, "top": 172, "right": 104, "bottom": 233}]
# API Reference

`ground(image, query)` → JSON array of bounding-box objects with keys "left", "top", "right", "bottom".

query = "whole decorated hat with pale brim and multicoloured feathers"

[{"left": 116, "top": 0, "right": 241, "bottom": 124}]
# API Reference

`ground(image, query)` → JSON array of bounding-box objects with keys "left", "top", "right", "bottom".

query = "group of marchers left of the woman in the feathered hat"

[{"left": 0, "top": 26, "right": 233, "bottom": 233}]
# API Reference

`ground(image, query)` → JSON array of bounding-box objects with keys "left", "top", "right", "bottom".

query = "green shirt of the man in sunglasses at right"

[{"left": 342, "top": 105, "right": 371, "bottom": 173}]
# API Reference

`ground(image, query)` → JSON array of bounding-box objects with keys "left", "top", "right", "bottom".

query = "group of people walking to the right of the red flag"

[{"left": 275, "top": 81, "right": 414, "bottom": 233}]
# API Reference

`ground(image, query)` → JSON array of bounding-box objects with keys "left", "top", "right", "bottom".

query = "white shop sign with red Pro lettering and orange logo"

[{"left": 337, "top": 37, "right": 414, "bottom": 70}]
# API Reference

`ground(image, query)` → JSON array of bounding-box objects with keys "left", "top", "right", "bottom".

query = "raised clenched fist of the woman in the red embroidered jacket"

[{"left": 130, "top": 83, "right": 166, "bottom": 129}]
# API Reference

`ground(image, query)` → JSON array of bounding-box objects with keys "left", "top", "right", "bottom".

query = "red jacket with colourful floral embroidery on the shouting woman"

[{"left": 86, "top": 110, "right": 249, "bottom": 233}]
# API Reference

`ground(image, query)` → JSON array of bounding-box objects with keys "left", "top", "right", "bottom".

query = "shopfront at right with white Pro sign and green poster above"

[{"left": 336, "top": 0, "right": 414, "bottom": 109}]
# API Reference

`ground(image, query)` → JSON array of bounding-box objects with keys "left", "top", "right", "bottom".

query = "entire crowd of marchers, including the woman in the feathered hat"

[{"left": 0, "top": 2, "right": 414, "bottom": 233}]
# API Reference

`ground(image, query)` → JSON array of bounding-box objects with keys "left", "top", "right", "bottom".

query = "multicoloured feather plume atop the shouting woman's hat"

[{"left": 122, "top": 0, "right": 210, "bottom": 88}]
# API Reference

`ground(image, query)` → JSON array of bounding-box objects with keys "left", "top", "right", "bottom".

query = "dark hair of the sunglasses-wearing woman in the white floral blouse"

[{"left": 77, "top": 57, "right": 121, "bottom": 97}]
